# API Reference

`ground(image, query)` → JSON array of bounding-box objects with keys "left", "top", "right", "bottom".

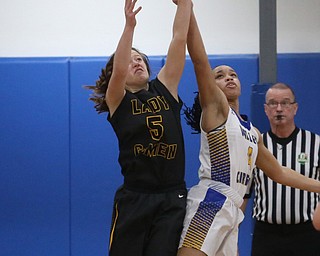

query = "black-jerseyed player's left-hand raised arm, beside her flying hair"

[{"left": 106, "top": 0, "right": 142, "bottom": 114}]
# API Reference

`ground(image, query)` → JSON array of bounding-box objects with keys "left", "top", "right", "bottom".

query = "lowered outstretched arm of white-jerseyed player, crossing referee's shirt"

[{"left": 256, "top": 130, "right": 320, "bottom": 193}]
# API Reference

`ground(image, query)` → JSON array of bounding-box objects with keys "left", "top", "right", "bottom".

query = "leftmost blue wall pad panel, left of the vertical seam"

[{"left": 0, "top": 58, "right": 70, "bottom": 256}]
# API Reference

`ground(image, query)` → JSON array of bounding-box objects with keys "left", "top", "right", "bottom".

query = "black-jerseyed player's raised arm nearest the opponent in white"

[{"left": 158, "top": 0, "right": 192, "bottom": 100}]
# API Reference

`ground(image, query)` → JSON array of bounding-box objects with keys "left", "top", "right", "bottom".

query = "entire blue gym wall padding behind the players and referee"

[{"left": 0, "top": 53, "right": 320, "bottom": 256}]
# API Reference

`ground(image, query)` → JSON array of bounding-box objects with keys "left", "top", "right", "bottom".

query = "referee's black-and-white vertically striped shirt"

[{"left": 253, "top": 127, "right": 320, "bottom": 224}]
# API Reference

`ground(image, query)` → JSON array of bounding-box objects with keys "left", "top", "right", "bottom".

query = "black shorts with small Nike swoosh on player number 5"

[{"left": 109, "top": 187, "right": 187, "bottom": 256}]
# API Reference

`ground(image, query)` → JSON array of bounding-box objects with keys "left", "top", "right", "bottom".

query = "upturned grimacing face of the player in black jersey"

[{"left": 126, "top": 50, "right": 149, "bottom": 88}]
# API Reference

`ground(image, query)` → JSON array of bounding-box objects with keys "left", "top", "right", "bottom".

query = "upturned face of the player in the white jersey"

[{"left": 213, "top": 65, "right": 241, "bottom": 100}]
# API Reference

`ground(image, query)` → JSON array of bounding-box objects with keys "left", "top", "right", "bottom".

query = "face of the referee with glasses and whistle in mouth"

[{"left": 264, "top": 88, "right": 298, "bottom": 125}]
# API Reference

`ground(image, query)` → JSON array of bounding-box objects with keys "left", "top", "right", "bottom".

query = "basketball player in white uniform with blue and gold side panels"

[{"left": 178, "top": 4, "right": 320, "bottom": 256}]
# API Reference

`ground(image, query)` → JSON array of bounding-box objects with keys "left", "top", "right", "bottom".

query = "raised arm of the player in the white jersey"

[{"left": 187, "top": 8, "right": 229, "bottom": 131}]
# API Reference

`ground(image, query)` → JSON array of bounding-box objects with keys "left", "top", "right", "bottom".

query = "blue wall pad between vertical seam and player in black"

[{"left": 70, "top": 58, "right": 114, "bottom": 256}]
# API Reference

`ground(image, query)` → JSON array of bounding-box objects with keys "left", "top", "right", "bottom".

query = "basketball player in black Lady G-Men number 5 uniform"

[{"left": 85, "top": 0, "right": 192, "bottom": 256}]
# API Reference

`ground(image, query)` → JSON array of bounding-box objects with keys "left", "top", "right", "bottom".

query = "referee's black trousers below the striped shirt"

[{"left": 252, "top": 221, "right": 320, "bottom": 256}]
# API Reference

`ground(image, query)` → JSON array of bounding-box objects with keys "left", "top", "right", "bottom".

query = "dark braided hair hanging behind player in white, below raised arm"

[{"left": 183, "top": 92, "right": 202, "bottom": 133}]
